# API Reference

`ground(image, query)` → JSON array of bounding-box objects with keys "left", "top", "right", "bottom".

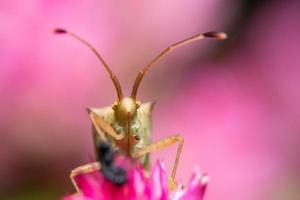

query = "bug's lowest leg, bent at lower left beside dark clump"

[{"left": 70, "top": 162, "right": 101, "bottom": 192}]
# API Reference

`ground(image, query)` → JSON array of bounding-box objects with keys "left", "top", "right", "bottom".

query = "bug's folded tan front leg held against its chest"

[{"left": 88, "top": 109, "right": 124, "bottom": 141}]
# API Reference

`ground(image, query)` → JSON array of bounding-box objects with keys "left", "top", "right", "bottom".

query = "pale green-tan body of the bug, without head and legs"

[{"left": 90, "top": 102, "right": 154, "bottom": 168}]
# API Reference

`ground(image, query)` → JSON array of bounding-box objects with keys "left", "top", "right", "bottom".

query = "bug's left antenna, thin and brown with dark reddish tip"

[{"left": 54, "top": 28, "right": 123, "bottom": 101}]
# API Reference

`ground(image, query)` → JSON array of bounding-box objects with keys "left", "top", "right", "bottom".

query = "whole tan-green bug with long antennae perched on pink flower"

[{"left": 55, "top": 29, "right": 227, "bottom": 188}]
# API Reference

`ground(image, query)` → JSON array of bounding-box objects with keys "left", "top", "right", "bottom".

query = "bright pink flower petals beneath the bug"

[{"left": 63, "top": 162, "right": 208, "bottom": 200}]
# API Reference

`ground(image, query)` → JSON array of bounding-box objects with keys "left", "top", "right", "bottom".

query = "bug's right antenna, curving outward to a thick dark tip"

[{"left": 131, "top": 32, "right": 227, "bottom": 99}]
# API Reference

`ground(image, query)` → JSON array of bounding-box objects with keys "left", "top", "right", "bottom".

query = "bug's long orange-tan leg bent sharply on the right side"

[{"left": 132, "top": 135, "right": 184, "bottom": 189}]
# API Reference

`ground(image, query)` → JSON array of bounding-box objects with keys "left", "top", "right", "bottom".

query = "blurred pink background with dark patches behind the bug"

[{"left": 0, "top": 0, "right": 300, "bottom": 200}]
